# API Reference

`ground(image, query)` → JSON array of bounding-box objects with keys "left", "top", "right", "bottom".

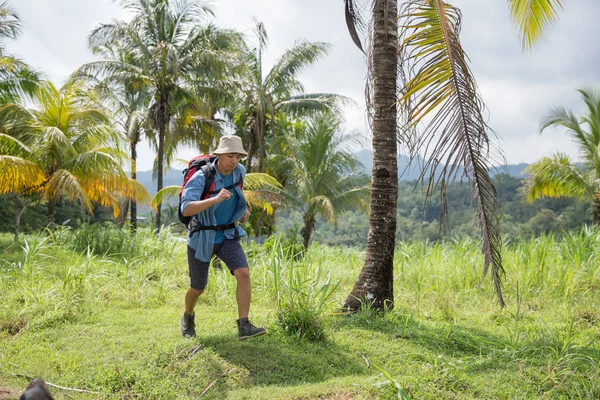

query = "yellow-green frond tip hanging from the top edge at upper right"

[{"left": 508, "top": 0, "right": 563, "bottom": 50}]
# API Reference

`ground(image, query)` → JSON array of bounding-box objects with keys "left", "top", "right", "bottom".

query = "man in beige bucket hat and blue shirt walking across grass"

[{"left": 180, "top": 135, "right": 266, "bottom": 340}]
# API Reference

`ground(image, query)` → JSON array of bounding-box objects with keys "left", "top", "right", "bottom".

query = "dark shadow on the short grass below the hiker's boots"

[{"left": 202, "top": 334, "right": 367, "bottom": 386}]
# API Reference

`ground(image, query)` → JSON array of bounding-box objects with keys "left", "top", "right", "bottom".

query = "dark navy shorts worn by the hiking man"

[{"left": 188, "top": 239, "right": 248, "bottom": 290}]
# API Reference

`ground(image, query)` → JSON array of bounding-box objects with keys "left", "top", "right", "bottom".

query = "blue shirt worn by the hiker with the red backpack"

[{"left": 181, "top": 160, "right": 247, "bottom": 262}]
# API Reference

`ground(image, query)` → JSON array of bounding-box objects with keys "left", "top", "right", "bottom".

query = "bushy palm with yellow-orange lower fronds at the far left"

[{"left": 0, "top": 82, "right": 149, "bottom": 234}]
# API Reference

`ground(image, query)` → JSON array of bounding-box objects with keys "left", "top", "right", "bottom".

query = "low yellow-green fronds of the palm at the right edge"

[{"left": 522, "top": 153, "right": 594, "bottom": 203}]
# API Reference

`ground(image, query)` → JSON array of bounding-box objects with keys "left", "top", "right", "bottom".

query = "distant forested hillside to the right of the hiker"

[{"left": 277, "top": 174, "right": 593, "bottom": 247}]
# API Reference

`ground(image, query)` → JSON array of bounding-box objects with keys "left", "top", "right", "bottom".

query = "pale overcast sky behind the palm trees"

[{"left": 9, "top": 0, "right": 600, "bottom": 170}]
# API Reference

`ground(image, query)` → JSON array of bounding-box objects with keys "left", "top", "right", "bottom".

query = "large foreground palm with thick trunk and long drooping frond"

[{"left": 344, "top": 0, "right": 562, "bottom": 310}]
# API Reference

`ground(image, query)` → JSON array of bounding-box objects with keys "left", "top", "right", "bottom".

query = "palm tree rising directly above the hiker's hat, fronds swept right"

[{"left": 235, "top": 21, "right": 346, "bottom": 172}]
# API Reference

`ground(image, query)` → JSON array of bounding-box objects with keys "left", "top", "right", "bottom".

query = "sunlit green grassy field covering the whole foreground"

[{"left": 0, "top": 223, "right": 600, "bottom": 399}]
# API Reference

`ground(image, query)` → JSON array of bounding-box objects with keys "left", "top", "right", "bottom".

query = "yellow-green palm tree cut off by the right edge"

[{"left": 523, "top": 89, "right": 600, "bottom": 225}]
